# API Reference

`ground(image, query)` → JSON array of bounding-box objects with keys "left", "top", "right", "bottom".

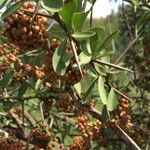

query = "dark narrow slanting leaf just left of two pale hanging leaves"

[{"left": 82, "top": 78, "right": 98, "bottom": 104}]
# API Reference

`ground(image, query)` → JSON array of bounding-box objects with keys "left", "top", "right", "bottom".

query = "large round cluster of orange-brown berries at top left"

[{"left": 4, "top": 2, "right": 48, "bottom": 50}]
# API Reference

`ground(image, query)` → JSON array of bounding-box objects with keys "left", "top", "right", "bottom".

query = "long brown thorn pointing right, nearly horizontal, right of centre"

[{"left": 92, "top": 59, "right": 134, "bottom": 73}]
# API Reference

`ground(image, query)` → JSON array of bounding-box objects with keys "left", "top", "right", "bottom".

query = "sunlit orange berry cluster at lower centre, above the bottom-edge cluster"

[{"left": 77, "top": 115, "right": 102, "bottom": 140}]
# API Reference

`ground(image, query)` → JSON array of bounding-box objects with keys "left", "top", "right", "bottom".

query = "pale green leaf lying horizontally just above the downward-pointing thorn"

[{"left": 72, "top": 31, "right": 95, "bottom": 41}]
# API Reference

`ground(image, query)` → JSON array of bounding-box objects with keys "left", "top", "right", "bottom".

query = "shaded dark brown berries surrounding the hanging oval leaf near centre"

[{"left": 44, "top": 38, "right": 83, "bottom": 87}]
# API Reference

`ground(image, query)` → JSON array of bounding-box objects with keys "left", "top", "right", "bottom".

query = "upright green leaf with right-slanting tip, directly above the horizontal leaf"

[{"left": 72, "top": 11, "right": 89, "bottom": 32}]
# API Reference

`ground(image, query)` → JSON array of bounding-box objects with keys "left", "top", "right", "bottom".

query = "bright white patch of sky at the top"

[{"left": 86, "top": 0, "right": 121, "bottom": 18}]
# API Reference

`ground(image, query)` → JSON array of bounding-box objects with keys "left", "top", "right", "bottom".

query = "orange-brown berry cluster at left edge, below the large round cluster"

[{"left": 0, "top": 40, "right": 45, "bottom": 81}]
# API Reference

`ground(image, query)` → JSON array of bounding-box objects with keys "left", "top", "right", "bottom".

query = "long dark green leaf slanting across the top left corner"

[{"left": 1, "top": 0, "right": 25, "bottom": 20}]
